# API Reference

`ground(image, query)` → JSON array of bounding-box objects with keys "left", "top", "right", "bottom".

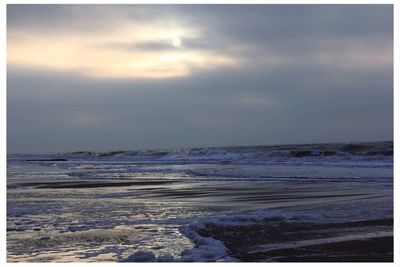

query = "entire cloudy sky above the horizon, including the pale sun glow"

[{"left": 7, "top": 5, "right": 393, "bottom": 153}]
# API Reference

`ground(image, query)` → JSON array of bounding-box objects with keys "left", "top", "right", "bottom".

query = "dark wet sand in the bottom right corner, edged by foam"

[{"left": 199, "top": 218, "right": 393, "bottom": 262}]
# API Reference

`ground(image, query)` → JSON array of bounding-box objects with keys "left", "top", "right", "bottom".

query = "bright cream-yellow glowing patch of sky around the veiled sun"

[{"left": 7, "top": 20, "right": 238, "bottom": 79}]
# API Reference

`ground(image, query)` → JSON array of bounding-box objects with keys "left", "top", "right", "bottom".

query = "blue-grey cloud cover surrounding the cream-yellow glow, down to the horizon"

[{"left": 7, "top": 5, "right": 393, "bottom": 153}]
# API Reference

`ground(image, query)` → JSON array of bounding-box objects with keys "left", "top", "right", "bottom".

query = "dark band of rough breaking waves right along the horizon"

[{"left": 9, "top": 142, "right": 393, "bottom": 167}]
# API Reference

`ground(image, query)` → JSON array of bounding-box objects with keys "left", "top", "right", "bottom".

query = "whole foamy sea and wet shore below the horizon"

[{"left": 7, "top": 142, "right": 393, "bottom": 262}]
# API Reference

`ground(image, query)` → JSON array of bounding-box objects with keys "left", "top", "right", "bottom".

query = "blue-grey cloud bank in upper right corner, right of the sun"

[{"left": 178, "top": 5, "right": 393, "bottom": 66}]
